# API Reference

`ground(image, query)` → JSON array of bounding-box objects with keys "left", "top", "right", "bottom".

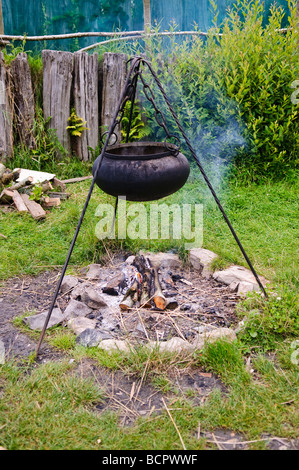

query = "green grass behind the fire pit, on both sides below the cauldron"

[{"left": 0, "top": 166, "right": 299, "bottom": 289}]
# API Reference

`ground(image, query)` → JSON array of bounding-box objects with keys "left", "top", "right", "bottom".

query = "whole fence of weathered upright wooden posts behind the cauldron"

[{"left": 0, "top": 50, "right": 128, "bottom": 161}]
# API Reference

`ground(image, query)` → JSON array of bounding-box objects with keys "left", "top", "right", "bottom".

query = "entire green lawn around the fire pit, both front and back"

[{"left": 0, "top": 165, "right": 299, "bottom": 450}]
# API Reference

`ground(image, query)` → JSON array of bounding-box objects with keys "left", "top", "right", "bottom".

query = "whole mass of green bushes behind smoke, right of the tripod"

[{"left": 123, "top": 0, "right": 299, "bottom": 180}]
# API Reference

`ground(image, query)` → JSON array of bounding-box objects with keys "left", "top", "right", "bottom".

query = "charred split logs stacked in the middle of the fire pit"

[{"left": 119, "top": 255, "right": 177, "bottom": 310}]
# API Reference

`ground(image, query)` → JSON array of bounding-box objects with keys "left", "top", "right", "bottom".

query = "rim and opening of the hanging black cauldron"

[{"left": 104, "top": 142, "right": 179, "bottom": 160}]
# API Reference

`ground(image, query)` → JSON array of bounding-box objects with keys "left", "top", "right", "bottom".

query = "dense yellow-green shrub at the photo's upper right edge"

[{"left": 215, "top": 1, "right": 299, "bottom": 179}]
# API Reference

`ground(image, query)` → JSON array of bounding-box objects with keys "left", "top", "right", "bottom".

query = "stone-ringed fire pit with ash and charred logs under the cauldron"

[{"left": 49, "top": 253, "right": 238, "bottom": 351}]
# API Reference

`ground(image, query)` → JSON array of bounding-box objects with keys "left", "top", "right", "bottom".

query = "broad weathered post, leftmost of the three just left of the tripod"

[{"left": 42, "top": 50, "right": 74, "bottom": 154}]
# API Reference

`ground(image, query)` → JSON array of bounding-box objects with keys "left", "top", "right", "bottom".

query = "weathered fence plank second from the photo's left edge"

[{"left": 10, "top": 52, "right": 35, "bottom": 149}]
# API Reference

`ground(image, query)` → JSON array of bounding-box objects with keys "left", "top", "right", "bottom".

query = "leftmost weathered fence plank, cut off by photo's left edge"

[{"left": 0, "top": 52, "right": 13, "bottom": 160}]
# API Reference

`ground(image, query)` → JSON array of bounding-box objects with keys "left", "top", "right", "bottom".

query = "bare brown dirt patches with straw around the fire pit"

[{"left": 0, "top": 271, "right": 298, "bottom": 450}]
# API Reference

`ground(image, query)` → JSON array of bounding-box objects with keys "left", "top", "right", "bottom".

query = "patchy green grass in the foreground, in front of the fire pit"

[{"left": 0, "top": 341, "right": 299, "bottom": 450}]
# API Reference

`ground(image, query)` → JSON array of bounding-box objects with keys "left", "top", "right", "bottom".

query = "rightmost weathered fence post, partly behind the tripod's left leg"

[{"left": 101, "top": 52, "right": 128, "bottom": 143}]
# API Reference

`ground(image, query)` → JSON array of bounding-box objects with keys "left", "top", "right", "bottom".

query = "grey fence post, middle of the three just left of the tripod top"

[{"left": 73, "top": 52, "right": 99, "bottom": 161}]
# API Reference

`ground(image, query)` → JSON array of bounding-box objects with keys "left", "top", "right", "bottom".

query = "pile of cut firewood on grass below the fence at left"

[{"left": 0, "top": 163, "right": 69, "bottom": 220}]
